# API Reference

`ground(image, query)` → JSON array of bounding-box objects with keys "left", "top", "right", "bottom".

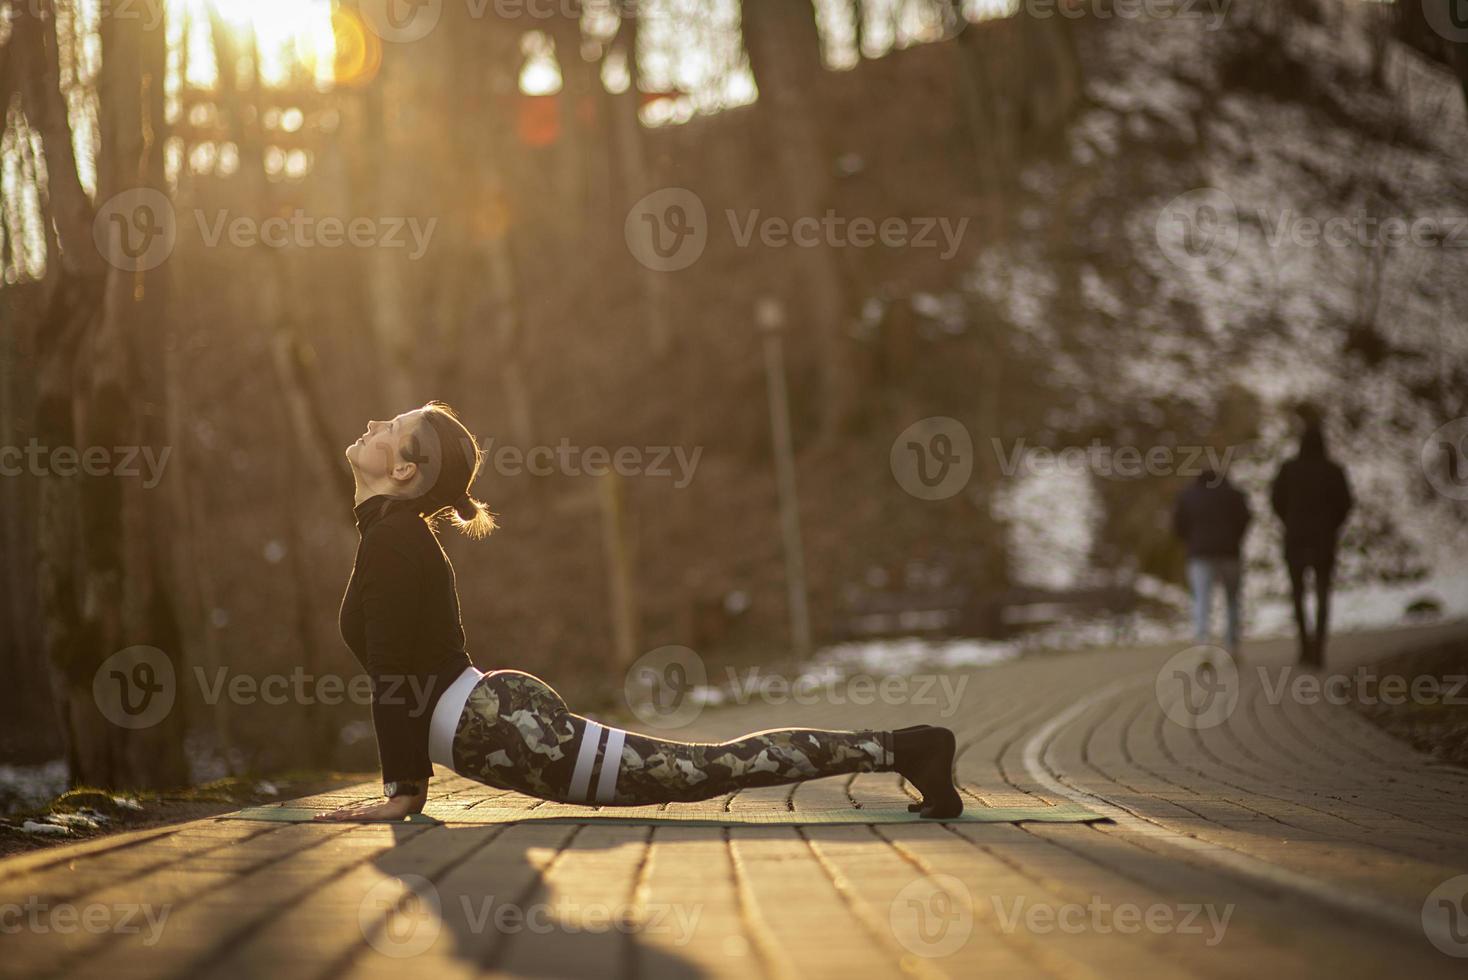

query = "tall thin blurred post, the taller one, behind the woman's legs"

[{"left": 755, "top": 296, "right": 810, "bottom": 659}]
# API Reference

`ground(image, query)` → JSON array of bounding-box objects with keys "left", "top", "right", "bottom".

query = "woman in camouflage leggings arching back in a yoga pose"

[{"left": 317, "top": 402, "right": 963, "bottom": 820}]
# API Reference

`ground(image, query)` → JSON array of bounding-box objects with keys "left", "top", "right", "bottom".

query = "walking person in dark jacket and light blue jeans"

[{"left": 1173, "top": 469, "right": 1249, "bottom": 657}]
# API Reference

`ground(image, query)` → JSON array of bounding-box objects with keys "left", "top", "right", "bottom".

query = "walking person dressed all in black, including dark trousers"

[{"left": 1270, "top": 421, "right": 1353, "bottom": 666}]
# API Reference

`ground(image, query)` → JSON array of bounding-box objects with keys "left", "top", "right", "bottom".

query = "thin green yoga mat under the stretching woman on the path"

[{"left": 217, "top": 804, "right": 1107, "bottom": 827}]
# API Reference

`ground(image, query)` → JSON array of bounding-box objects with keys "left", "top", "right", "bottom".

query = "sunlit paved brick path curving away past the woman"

[{"left": 0, "top": 628, "right": 1468, "bottom": 980}]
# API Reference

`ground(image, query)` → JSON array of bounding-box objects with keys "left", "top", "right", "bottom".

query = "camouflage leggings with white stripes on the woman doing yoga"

[{"left": 454, "top": 670, "right": 893, "bottom": 807}]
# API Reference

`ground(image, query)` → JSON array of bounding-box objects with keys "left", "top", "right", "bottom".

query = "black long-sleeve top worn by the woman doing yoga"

[{"left": 341, "top": 496, "right": 470, "bottom": 782}]
